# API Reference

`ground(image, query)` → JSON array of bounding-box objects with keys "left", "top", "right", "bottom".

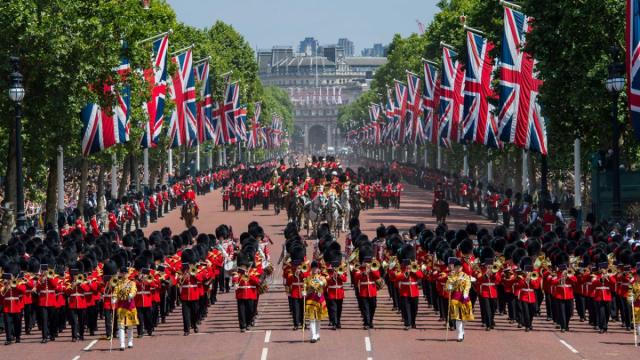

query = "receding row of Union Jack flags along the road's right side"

[{"left": 347, "top": 7, "right": 547, "bottom": 155}]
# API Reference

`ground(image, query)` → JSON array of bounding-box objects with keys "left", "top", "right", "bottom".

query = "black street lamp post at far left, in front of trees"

[{"left": 9, "top": 56, "right": 26, "bottom": 233}]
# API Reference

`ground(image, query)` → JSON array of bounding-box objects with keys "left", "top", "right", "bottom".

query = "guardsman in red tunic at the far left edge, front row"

[{"left": 0, "top": 272, "right": 27, "bottom": 345}]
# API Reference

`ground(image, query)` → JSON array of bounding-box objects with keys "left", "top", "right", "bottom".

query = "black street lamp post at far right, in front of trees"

[{"left": 606, "top": 46, "right": 625, "bottom": 220}]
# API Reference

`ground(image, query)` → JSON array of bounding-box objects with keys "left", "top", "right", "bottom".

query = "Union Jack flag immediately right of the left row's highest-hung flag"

[{"left": 169, "top": 49, "right": 198, "bottom": 148}]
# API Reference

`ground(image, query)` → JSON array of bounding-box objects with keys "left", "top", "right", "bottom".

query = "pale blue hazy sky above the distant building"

[{"left": 167, "top": 0, "right": 437, "bottom": 54}]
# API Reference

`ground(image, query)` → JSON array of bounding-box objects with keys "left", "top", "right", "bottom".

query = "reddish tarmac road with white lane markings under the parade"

[{"left": 8, "top": 179, "right": 640, "bottom": 360}]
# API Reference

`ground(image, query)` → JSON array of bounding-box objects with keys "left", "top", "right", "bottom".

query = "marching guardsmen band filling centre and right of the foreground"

[{"left": 276, "top": 220, "right": 640, "bottom": 341}]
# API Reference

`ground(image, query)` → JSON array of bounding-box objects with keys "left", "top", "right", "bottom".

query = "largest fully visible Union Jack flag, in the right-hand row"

[{"left": 498, "top": 8, "right": 547, "bottom": 155}]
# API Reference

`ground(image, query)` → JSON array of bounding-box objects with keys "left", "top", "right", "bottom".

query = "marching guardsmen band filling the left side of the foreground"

[{"left": 0, "top": 222, "right": 270, "bottom": 350}]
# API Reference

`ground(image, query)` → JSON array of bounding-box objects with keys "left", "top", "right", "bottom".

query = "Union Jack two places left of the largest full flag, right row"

[{"left": 438, "top": 47, "right": 464, "bottom": 146}]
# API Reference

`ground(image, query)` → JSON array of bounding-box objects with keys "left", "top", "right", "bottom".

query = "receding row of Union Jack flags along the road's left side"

[{"left": 80, "top": 34, "right": 283, "bottom": 156}]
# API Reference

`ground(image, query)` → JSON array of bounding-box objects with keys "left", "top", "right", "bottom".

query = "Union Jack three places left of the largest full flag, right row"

[{"left": 422, "top": 61, "right": 440, "bottom": 145}]
